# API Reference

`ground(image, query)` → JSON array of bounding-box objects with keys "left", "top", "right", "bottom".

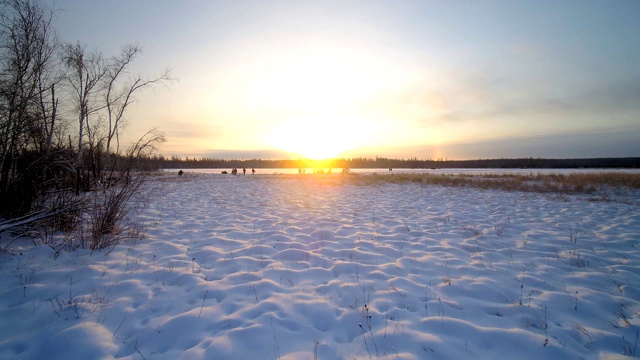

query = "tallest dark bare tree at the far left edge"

[{"left": 0, "top": 0, "right": 57, "bottom": 212}]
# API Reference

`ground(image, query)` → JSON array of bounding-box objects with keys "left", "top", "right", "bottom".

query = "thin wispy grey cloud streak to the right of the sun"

[{"left": 403, "top": 73, "right": 640, "bottom": 126}]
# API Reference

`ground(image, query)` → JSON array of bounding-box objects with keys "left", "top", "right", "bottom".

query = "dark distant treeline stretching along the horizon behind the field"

[{"left": 156, "top": 156, "right": 640, "bottom": 169}]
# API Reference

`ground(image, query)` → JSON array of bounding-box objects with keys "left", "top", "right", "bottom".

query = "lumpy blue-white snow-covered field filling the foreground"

[{"left": 0, "top": 174, "right": 640, "bottom": 359}]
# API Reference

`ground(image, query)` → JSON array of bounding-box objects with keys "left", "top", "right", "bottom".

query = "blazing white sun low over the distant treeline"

[{"left": 270, "top": 115, "right": 366, "bottom": 160}]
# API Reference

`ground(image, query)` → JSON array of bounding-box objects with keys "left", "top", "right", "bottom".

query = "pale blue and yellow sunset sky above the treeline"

[{"left": 52, "top": 0, "right": 640, "bottom": 159}]
